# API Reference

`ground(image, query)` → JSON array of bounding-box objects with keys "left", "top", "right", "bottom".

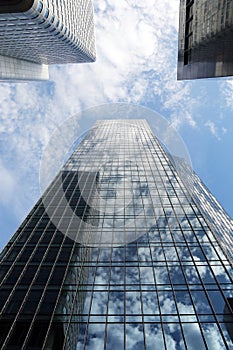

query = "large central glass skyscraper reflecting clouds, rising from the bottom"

[{"left": 0, "top": 119, "right": 233, "bottom": 350}]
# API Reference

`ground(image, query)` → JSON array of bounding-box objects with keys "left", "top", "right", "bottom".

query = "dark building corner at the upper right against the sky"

[{"left": 177, "top": 0, "right": 233, "bottom": 80}]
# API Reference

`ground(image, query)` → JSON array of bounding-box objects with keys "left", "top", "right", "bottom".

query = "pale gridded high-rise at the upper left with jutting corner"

[{"left": 0, "top": 0, "right": 95, "bottom": 80}]
